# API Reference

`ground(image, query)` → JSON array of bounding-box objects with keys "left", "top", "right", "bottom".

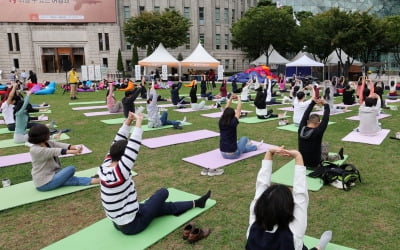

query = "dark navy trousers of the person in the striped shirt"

[{"left": 114, "top": 188, "right": 193, "bottom": 235}]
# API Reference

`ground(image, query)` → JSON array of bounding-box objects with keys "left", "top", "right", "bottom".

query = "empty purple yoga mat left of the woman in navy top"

[{"left": 142, "top": 129, "right": 219, "bottom": 148}]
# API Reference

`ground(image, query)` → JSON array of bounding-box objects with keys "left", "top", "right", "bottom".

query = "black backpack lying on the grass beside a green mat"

[{"left": 308, "top": 162, "right": 361, "bottom": 191}]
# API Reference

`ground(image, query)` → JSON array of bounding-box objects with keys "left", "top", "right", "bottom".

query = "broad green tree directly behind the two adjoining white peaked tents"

[{"left": 123, "top": 9, "right": 191, "bottom": 52}]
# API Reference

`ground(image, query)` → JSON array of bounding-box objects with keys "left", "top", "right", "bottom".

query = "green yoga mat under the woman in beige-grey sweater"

[{"left": 0, "top": 167, "right": 137, "bottom": 211}]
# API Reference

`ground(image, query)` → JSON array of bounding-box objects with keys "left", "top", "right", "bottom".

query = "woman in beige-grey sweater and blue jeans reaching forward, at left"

[{"left": 28, "top": 124, "right": 100, "bottom": 191}]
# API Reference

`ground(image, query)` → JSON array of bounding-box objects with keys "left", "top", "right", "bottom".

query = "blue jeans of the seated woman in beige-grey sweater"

[{"left": 36, "top": 166, "right": 92, "bottom": 191}]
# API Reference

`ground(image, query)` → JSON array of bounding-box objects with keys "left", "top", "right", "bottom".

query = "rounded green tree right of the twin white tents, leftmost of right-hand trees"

[{"left": 231, "top": 6, "right": 302, "bottom": 64}]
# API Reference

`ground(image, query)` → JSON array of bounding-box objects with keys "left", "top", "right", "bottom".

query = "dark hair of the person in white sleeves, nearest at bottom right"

[{"left": 254, "top": 184, "right": 294, "bottom": 230}]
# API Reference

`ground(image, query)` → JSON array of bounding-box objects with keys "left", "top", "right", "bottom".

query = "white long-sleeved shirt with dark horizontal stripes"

[{"left": 98, "top": 124, "right": 143, "bottom": 225}]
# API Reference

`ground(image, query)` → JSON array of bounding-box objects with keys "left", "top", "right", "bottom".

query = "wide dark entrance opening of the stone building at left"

[{"left": 42, "top": 48, "right": 85, "bottom": 73}]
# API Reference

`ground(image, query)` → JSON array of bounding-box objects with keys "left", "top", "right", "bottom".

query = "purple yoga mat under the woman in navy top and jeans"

[{"left": 182, "top": 141, "right": 273, "bottom": 169}]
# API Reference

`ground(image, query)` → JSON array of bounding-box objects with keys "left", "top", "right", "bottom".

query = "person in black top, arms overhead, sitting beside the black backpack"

[{"left": 298, "top": 97, "right": 344, "bottom": 170}]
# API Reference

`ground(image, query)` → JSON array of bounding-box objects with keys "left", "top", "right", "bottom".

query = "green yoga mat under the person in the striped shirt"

[{"left": 44, "top": 188, "right": 216, "bottom": 250}]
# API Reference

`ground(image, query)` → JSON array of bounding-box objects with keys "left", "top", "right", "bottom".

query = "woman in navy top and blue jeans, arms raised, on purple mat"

[{"left": 214, "top": 94, "right": 263, "bottom": 175}]
